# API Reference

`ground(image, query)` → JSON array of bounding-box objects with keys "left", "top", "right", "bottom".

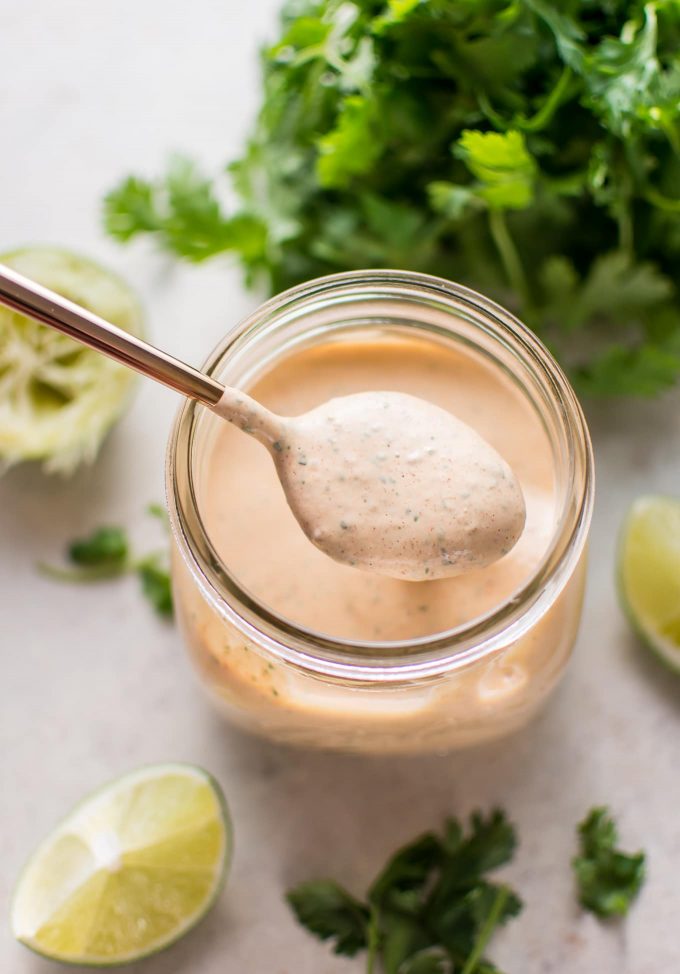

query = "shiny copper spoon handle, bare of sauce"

[{"left": 0, "top": 264, "right": 224, "bottom": 406}]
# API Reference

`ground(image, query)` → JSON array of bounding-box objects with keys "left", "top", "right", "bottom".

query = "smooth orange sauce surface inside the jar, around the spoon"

[{"left": 199, "top": 337, "right": 555, "bottom": 640}]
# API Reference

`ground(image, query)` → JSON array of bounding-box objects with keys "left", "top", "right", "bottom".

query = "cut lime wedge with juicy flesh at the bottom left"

[{"left": 12, "top": 764, "right": 231, "bottom": 966}]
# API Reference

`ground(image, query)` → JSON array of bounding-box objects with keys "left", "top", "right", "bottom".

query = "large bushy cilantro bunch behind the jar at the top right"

[{"left": 105, "top": 0, "right": 680, "bottom": 395}]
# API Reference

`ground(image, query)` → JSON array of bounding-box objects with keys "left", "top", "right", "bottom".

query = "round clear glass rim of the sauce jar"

[{"left": 166, "top": 270, "right": 594, "bottom": 682}]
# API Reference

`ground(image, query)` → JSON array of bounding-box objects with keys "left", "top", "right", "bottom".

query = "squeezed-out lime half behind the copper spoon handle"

[{"left": 0, "top": 247, "right": 143, "bottom": 473}]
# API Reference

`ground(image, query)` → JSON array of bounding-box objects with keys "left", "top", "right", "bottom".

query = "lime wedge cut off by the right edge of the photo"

[{"left": 619, "top": 497, "right": 680, "bottom": 672}]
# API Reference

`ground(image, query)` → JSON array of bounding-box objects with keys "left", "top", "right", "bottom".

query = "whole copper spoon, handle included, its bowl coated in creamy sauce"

[{"left": 0, "top": 265, "right": 525, "bottom": 581}]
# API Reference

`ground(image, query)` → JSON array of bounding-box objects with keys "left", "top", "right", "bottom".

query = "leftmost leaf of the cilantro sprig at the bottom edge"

[{"left": 286, "top": 879, "right": 370, "bottom": 957}]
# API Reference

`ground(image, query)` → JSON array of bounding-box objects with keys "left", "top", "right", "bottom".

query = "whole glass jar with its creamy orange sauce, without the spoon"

[{"left": 167, "top": 271, "right": 593, "bottom": 753}]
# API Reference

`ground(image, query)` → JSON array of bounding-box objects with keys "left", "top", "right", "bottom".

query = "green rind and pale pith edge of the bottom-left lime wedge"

[{"left": 11, "top": 763, "right": 233, "bottom": 967}]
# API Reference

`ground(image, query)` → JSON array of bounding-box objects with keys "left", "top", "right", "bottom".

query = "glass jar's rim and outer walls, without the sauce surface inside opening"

[{"left": 167, "top": 271, "right": 593, "bottom": 753}]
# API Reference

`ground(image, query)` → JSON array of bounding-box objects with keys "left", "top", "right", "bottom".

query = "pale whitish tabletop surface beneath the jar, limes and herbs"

[{"left": 0, "top": 0, "right": 680, "bottom": 974}]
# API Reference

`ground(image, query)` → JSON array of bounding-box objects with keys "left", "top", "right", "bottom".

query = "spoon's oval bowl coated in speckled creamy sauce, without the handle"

[{"left": 272, "top": 392, "right": 526, "bottom": 581}]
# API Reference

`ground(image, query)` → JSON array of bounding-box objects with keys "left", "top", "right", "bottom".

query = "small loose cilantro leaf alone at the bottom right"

[{"left": 572, "top": 808, "right": 645, "bottom": 918}]
